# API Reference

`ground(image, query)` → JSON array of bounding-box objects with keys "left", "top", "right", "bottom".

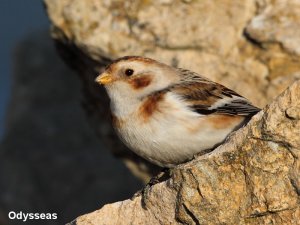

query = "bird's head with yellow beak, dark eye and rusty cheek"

[{"left": 96, "top": 56, "right": 180, "bottom": 99}]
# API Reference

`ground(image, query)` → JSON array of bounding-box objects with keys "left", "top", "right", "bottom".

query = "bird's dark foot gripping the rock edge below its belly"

[{"left": 131, "top": 168, "right": 171, "bottom": 209}]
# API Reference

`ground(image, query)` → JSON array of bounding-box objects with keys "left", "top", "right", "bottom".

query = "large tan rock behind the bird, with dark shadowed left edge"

[{"left": 44, "top": 0, "right": 300, "bottom": 181}]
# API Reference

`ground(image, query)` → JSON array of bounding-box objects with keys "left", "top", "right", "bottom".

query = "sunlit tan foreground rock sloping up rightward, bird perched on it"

[{"left": 68, "top": 81, "right": 300, "bottom": 225}]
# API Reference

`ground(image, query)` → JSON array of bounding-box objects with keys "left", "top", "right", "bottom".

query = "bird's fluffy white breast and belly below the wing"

[{"left": 116, "top": 93, "right": 240, "bottom": 167}]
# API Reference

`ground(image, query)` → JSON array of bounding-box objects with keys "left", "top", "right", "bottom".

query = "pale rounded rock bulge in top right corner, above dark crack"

[{"left": 246, "top": 0, "right": 300, "bottom": 56}]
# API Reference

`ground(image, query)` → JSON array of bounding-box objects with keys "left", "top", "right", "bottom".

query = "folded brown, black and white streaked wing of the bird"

[{"left": 170, "top": 69, "right": 260, "bottom": 116}]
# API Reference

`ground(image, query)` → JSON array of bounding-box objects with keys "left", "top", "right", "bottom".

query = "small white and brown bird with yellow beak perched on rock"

[{"left": 96, "top": 56, "right": 260, "bottom": 168}]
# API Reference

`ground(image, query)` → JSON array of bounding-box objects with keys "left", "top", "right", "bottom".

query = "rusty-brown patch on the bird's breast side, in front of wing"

[{"left": 139, "top": 93, "right": 164, "bottom": 121}]
